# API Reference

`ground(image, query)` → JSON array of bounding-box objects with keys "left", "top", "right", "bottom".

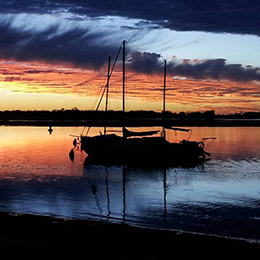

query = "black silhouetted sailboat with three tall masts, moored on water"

[{"left": 80, "top": 41, "right": 210, "bottom": 167}]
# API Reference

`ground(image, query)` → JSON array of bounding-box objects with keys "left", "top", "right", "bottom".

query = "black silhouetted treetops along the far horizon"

[{"left": 0, "top": 108, "right": 260, "bottom": 120}]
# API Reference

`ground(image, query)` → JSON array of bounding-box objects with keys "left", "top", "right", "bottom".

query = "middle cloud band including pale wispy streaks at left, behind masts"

[{"left": 0, "top": 11, "right": 260, "bottom": 82}]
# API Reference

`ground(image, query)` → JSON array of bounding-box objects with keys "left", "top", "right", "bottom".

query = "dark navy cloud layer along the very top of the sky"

[{"left": 0, "top": 0, "right": 260, "bottom": 36}]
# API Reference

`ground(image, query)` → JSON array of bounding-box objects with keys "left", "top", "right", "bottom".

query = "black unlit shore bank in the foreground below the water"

[{"left": 0, "top": 212, "right": 260, "bottom": 259}]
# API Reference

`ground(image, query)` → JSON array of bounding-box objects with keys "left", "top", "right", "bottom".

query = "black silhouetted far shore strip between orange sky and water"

[{"left": 0, "top": 108, "right": 260, "bottom": 126}]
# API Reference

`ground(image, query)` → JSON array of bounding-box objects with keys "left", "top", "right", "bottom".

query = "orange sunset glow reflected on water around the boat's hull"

[{"left": 0, "top": 127, "right": 260, "bottom": 181}]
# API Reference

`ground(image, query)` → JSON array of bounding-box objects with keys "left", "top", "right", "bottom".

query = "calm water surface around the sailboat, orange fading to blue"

[{"left": 0, "top": 127, "right": 260, "bottom": 240}]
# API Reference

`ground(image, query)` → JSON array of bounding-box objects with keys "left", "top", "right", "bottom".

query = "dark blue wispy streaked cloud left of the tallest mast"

[{"left": 0, "top": 18, "right": 118, "bottom": 68}]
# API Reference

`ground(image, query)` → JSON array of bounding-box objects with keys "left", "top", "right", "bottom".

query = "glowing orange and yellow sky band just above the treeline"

[{"left": 0, "top": 61, "right": 260, "bottom": 113}]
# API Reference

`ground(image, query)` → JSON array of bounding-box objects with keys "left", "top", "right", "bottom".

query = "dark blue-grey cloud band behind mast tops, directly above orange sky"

[{"left": 0, "top": 12, "right": 260, "bottom": 82}]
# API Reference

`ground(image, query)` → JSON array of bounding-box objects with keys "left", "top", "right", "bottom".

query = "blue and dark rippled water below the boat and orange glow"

[{"left": 0, "top": 160, "right": 260, "bottom": 239}]
